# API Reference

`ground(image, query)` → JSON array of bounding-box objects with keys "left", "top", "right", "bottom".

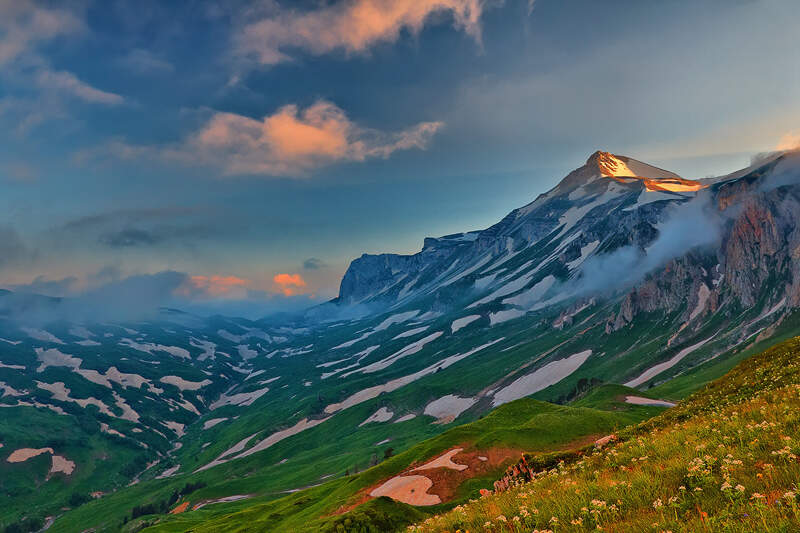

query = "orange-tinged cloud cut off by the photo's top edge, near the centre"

[{"left": 236, "top": 0, "right": 485, "bottom": 65}]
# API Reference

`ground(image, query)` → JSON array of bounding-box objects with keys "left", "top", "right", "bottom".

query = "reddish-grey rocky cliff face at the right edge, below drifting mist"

[{"left": 610, "top": 156, "right": 800, "bottom": 330}]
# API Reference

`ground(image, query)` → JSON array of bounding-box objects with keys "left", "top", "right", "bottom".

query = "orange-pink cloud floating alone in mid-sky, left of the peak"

[{"left": 169, "top": 101, "right": 443, "bottom": 176}]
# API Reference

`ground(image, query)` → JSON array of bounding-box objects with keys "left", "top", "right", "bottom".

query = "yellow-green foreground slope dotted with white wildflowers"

[{"left": 410, "top": 337, "right": 800, "bottom": 532}]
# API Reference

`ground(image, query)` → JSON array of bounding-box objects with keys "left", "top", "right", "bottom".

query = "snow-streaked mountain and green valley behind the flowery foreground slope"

[{"left": 0, "top": 148, "right": 800, "bottom": 532}]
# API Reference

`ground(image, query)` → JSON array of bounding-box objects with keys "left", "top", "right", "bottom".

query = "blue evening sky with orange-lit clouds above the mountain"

[{"left": 0, "top": 0, "right": 800, "bottom": 317}]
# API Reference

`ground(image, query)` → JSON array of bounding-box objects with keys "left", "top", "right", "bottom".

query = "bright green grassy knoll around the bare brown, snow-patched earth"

[{"left": 119, "top": 389, "right": 662, "bottom": 533}]
